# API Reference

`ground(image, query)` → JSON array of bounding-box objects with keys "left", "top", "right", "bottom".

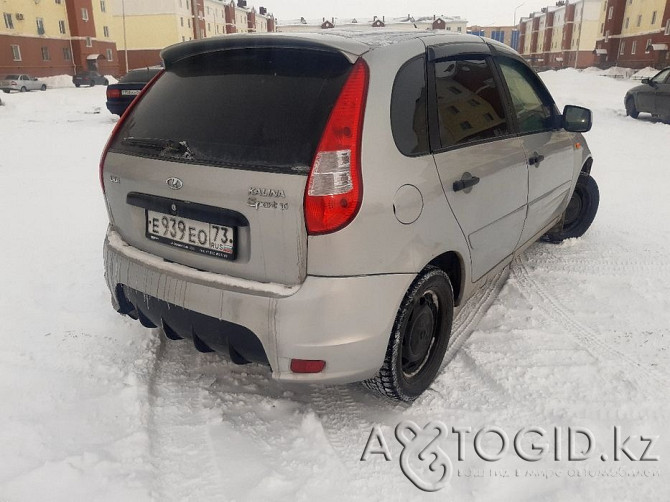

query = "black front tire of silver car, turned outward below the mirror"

[{"left": 542, "top": 174, "right": 600, "bottom": 244}]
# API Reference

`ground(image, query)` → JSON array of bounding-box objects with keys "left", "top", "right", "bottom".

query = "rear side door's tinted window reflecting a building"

[{"left": 434, "top": 56, "right": 509, "bottom": 148}]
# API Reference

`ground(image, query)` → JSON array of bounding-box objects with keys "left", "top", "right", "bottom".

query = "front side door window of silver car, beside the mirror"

[{"left": 498, "top": 58, "right": 554, "bottom": 133}]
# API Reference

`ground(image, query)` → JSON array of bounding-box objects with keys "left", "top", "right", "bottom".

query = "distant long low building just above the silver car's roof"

[{"left": 277, "top": 14, "right": 468, "bottom": 33}]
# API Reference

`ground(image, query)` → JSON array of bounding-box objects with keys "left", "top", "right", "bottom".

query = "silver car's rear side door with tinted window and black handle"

[{"left": 428, "top": 44, "right": 528, "bottom": 281}]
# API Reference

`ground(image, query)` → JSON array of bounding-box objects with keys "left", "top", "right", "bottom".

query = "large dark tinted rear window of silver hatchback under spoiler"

[{"left": 110, "top": 48, "right": 352, "bottom": 173}]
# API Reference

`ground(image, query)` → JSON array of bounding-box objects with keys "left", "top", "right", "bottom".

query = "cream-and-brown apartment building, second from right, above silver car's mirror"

[{"left": 518, "top": 0, "right": 604, "bottom": 68}]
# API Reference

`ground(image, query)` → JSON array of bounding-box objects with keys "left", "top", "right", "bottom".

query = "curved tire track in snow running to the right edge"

[{"left": 512, "top": 256, "right": 670, "bottom": 392}]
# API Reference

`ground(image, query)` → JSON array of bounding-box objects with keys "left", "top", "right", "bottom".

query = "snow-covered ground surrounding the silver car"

[{"left": 0, "top": 70, "right": 670, "bottom": 501}]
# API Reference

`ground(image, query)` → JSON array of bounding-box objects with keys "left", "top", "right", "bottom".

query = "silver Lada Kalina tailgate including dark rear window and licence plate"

[{"left": 103, "top": 47, "right": 351, "bottom": 285}]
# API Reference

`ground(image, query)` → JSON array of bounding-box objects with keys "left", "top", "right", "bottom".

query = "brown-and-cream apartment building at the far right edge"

[{"left": 596, "top": 0, "right": 670, "bottom": 68}]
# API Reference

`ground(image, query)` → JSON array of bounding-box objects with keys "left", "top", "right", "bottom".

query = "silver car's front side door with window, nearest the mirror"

[{"left": 496, "top": 56, "right": 575, "bottom": 244}]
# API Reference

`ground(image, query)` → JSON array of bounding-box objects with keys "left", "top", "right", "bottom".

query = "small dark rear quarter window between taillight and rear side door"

[{"left": 391, "top": 57, "right": 429, "bottom": 156}]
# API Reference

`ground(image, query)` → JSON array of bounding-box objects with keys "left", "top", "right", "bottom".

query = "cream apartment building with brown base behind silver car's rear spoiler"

[{"left": 114, "top": 0, "right": 275, "bottom": 72}]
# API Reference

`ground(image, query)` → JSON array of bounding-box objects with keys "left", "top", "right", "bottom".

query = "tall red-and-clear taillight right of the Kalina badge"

[{"left": 305, "top": 59, "right": 369, "bottom": 235}]
